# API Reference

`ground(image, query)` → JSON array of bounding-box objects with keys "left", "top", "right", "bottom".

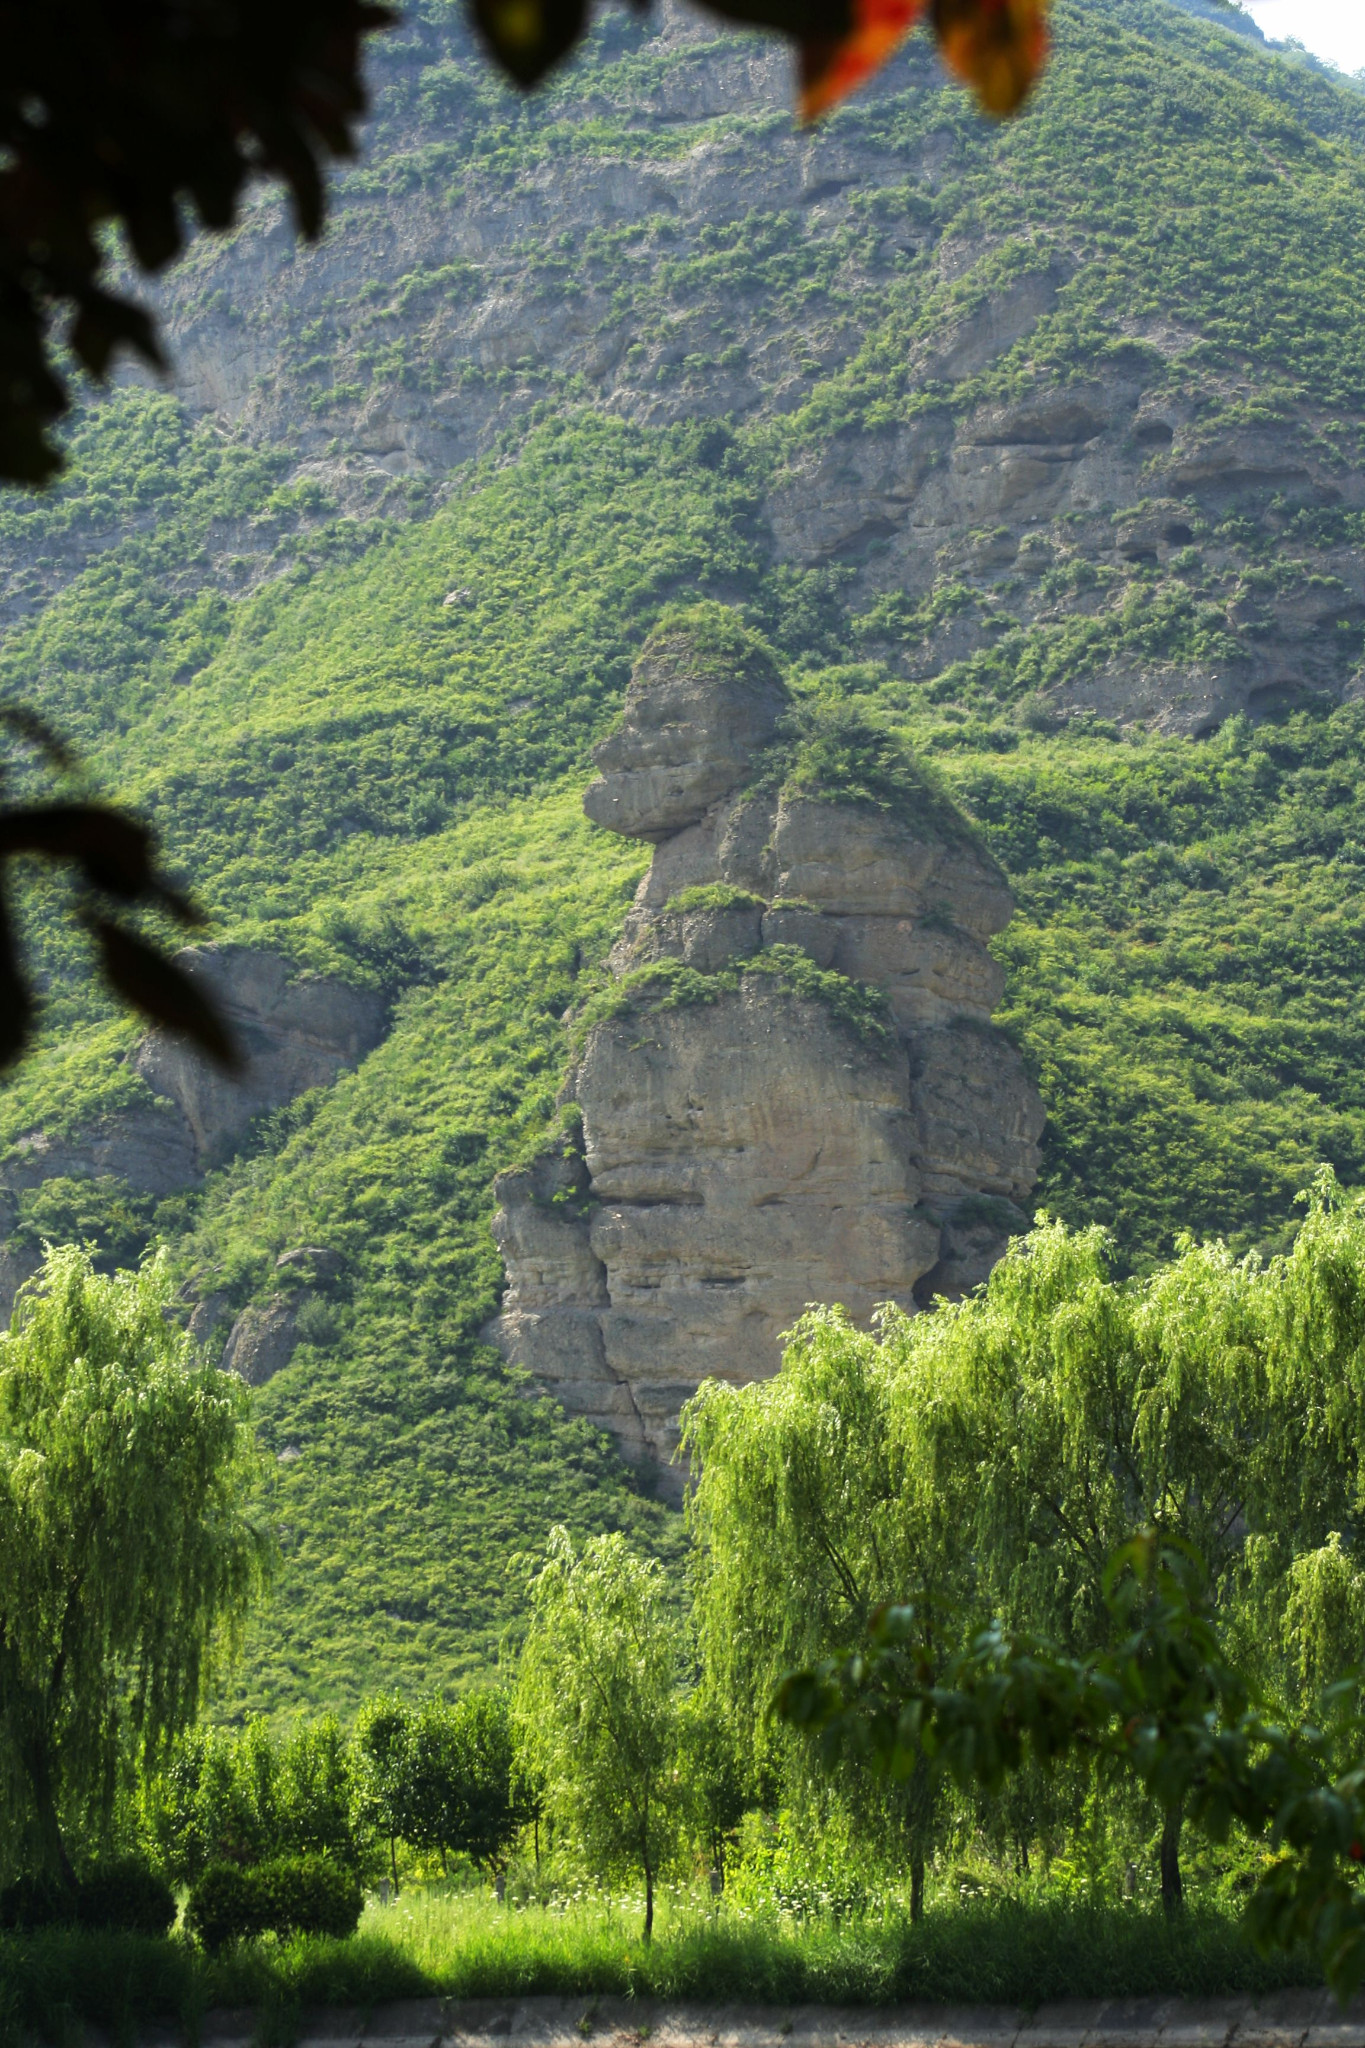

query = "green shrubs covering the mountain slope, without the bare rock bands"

[{"left": 0, "top": 0, "right": 1365, "bottom": 1716}]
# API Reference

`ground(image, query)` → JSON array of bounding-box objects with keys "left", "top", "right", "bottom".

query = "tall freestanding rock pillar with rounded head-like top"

[{"left": 491, "top": 627, "right": 1044, "bottom": 1489}]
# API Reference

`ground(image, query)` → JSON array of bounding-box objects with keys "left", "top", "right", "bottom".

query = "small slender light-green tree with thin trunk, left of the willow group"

[{"left": 514, "top": 1528, "right": 681, "bottom": 1942}]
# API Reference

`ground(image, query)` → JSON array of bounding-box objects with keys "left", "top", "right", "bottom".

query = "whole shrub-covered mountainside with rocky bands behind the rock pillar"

[{"left": 0, "top": 0, "right": 1365, "bottom": 1712}]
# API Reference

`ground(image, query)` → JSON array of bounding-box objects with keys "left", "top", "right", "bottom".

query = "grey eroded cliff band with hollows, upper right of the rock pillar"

[{"left": 765, "top": 372, "right": 1365, "bottom": 735}]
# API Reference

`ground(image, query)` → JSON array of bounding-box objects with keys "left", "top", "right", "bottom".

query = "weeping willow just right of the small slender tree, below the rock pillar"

[{"left": 684, "top": 1309, "right": 970, "bottom": 1919}]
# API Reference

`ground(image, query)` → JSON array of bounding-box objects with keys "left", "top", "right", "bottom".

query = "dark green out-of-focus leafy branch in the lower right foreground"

[{"left": 780, "top": 1532, "right": 1365, "bottom": 2001}]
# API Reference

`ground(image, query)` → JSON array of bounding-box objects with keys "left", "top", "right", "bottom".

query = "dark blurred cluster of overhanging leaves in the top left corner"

[{"left": 0, "top": 0, "right": 395, "bottom": 483}]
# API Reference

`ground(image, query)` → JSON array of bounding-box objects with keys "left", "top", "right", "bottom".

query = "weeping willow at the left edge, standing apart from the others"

[{"left": 0, "top": 1247, "right": 272, "bottom": 1882}]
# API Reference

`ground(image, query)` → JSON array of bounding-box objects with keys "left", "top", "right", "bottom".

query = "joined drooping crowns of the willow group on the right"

[{"left": 749, "top": 1176, "right": 1365, "bottom": 1907}]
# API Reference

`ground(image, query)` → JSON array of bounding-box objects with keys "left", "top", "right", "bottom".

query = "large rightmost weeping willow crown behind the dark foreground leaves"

[{"left": 884, "top": 1176, "right": 1365, "bottom": 1905}]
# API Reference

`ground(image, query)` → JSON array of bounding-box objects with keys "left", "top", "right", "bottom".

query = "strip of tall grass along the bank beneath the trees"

[{"left": 0, "top": 1890, "right": 1318, "bottom": 2042}]
